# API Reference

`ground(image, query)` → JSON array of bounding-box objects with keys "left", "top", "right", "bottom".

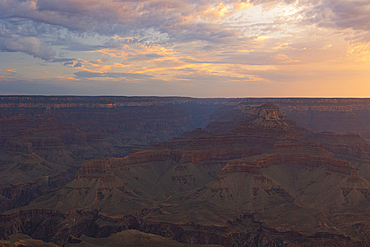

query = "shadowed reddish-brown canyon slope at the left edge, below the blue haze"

[{"left": 0, "top": 140, "right": 75, "bottom": 212}]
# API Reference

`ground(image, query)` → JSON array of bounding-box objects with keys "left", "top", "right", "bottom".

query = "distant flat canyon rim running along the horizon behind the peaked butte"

[{"left": 0, "top": 96, "right": 370, "bottom": 133}]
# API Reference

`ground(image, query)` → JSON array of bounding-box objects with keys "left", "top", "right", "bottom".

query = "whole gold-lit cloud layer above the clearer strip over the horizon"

[{"left": 0, "top": 0, "right": 370, "bottom": 98}]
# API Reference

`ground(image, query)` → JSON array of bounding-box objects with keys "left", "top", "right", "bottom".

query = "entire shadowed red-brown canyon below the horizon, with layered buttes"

[{"left": 0, "top": 96, "right": 370, "bottom": 246}]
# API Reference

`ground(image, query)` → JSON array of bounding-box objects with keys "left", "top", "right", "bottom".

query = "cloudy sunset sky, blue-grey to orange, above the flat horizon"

[{"left": 0, "top": 0, "right": 370, "bottom": 97}]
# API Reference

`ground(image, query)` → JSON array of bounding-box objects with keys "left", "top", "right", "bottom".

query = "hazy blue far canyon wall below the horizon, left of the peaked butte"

[{"left": 0, "top": 96, "right": 228, "bottom": 139}]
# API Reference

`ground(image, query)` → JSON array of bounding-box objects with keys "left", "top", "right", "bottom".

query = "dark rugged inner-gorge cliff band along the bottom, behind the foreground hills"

[{"left": 0, "top": 210, "right": 365, "bottom": 247}]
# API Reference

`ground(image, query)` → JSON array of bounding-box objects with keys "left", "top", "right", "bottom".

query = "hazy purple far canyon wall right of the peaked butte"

[{"left": 211, "top": 98, "right": 370, "bottom": 137}]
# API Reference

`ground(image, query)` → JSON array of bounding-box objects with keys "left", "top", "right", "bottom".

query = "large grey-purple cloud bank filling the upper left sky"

[{"left": 0, "top": 0, "right": 304, "bottom": 60}]
